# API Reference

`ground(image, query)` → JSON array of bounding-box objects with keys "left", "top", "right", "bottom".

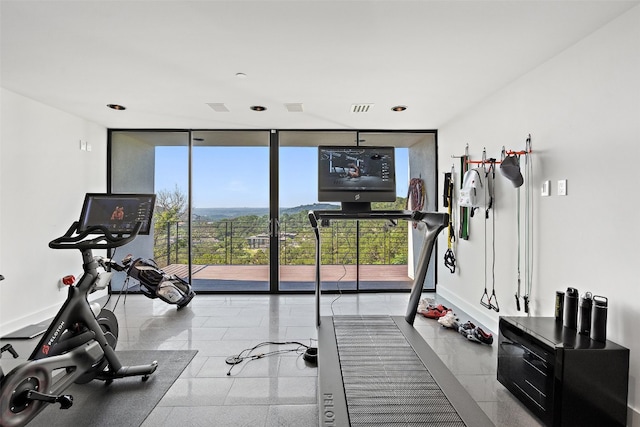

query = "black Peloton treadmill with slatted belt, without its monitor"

[{"left": 309, "top": 210, "right": 493, "bottom": 427}]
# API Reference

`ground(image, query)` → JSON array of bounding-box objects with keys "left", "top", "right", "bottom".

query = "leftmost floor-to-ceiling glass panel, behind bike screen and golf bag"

[{"left": 108, "top": 130, "right": 190, "bottom": 291}]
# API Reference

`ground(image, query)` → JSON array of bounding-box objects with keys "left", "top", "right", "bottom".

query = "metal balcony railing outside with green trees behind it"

[{"left": 154, "top": 217, "right": 408, "bottom": 267}]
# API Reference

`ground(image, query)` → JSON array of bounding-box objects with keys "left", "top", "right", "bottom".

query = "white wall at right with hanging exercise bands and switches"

[{"left": 438, "top": 7, "right": 640, "bottom": 426}]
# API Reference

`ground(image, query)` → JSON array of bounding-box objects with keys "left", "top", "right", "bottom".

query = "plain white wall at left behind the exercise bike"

[{"left": 0, "top": 89, "right": 107, "bottom": 335}]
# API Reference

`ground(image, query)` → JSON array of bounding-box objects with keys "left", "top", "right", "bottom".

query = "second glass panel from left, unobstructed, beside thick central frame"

[{"left": 191, "top": 131, "right": 270, "bottom": 292}]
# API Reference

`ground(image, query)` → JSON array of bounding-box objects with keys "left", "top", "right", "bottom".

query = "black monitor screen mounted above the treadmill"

[{"left": 318, "top": 146, "right": 396, "bottom": 210}]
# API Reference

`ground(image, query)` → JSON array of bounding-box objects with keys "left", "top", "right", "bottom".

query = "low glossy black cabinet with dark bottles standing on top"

[{"left": 498, "top": 317, "right": 629, "bottom": 427}]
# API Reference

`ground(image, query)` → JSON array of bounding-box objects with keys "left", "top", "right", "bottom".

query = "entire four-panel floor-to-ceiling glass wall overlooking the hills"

[{"left": 109, "top": 130, "right": 437, "bottom": 292}]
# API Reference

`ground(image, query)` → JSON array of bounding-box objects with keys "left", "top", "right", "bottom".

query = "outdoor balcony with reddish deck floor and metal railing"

[{"left": 154, "top": 219, "right": 413, "bottom": 292}]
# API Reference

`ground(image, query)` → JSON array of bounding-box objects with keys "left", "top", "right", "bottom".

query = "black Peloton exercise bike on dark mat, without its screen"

[{"left": 0, "top": 195, "right": 158, "bottom": 427}]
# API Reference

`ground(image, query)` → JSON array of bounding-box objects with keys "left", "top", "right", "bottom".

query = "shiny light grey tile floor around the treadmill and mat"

[{"left": 3, "top": 293, "right": 541, "bottom": 427}]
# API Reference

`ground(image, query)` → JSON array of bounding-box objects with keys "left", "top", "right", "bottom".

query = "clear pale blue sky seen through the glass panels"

[{"left": 155, "top": 146, "right": 409, "bottom": 208}]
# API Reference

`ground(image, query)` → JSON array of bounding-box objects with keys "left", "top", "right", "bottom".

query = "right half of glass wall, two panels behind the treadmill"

[{"left": 279, "top": 131, "right": 436, "bottom": 291}]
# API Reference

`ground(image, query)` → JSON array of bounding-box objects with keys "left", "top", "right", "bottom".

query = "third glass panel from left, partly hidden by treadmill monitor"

[{"left": 278, "top": 131, "right": 357, "bottom": 291}]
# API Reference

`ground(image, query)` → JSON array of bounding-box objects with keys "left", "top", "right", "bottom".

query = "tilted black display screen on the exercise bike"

[{"left": 78, "top": 193, "right": 156, "bottom": 235}]
